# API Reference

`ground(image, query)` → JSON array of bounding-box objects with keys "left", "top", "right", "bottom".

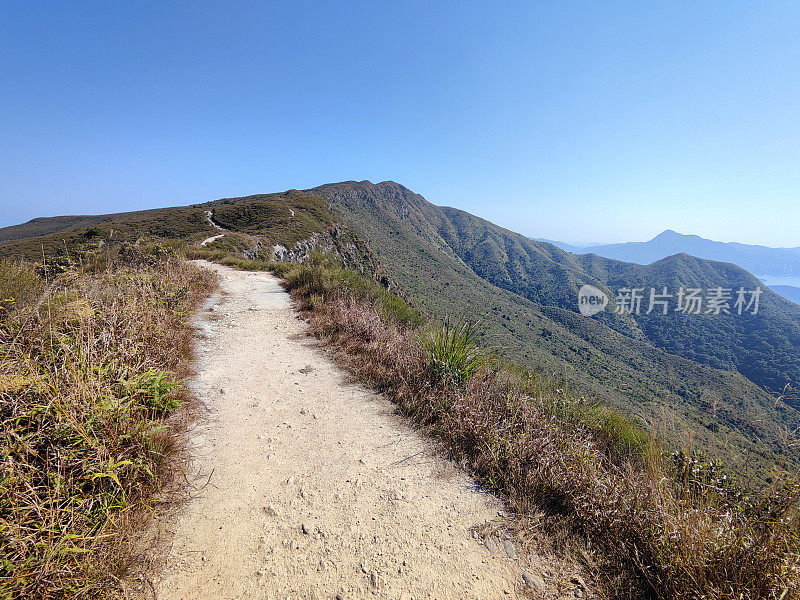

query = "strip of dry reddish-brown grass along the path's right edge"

[{"left": 278, "top": 265, "right": 800, "bottom": 600}]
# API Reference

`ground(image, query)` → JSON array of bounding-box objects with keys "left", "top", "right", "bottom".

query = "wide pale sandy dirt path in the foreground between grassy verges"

[{"left": 157, "top": 263, "right": 564, "bottom": 600}]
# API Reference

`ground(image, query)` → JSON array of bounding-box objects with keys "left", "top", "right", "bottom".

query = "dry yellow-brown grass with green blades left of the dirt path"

[{"left": 0, "top": 248, "right": 214, "bottom": 599}]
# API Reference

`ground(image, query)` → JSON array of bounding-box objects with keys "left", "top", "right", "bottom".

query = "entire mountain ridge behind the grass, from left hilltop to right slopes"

[{"left": 0, "top": 181, "right": 800, "bottom": 472}]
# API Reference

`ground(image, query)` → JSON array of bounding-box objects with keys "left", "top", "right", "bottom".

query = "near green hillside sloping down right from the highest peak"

[{"left": 311, "top": 182, "right": 800, "bottom": 480}]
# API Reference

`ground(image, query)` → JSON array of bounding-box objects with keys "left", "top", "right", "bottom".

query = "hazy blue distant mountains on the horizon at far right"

[{"left": 537, "top": 229, "right": 800, "bottom": 303}]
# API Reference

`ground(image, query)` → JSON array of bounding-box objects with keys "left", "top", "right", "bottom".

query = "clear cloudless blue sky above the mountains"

[{"left": 0, "top": 0, "right": 800, "bottom": 246}]
